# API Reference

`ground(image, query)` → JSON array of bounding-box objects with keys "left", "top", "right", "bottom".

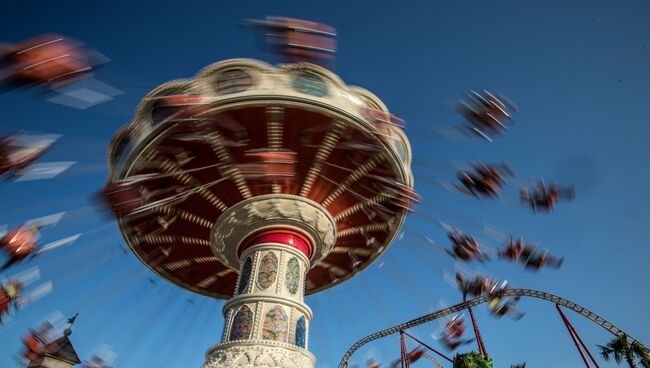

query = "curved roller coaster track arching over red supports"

[{"left": 339, "top": 289, "right": 649, "bottom": 368}]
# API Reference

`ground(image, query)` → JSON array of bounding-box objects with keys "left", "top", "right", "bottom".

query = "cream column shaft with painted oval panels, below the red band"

[{"left": 204, "top": 236, "right": 315, "bottom": 368}]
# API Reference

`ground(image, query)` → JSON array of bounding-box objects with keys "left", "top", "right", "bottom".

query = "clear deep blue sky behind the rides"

[{"left": 0, "top": 0, "right": 650, "bottom": 368}]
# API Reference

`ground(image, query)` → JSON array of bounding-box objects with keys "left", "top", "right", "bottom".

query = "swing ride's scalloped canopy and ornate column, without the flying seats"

[{"left": 106, "top": 15, "right": 417, "bottom": 368}]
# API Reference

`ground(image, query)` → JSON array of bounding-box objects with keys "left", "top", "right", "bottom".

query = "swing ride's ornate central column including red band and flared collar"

[{"left": 203, "top": 195, "right": 334, "bottom": 368}]
